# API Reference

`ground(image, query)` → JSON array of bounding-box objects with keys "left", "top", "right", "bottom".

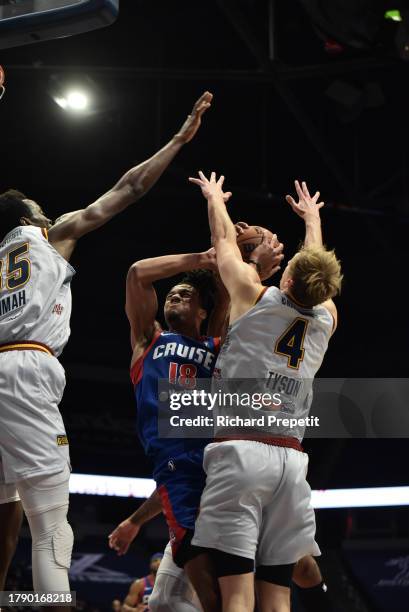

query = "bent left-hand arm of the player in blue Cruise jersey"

[{"left": 125, "top": 250, "right": 216, "bottom": 350}]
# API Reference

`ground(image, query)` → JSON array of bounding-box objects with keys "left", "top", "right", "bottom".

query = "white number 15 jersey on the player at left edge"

[{"left": 0, "top": 225, "right": 75, "bottom": 357}]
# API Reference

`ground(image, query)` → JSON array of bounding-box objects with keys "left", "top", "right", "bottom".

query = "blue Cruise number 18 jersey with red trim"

[{"left": 131, "top": 332, "right": 220, "bottom": 477}]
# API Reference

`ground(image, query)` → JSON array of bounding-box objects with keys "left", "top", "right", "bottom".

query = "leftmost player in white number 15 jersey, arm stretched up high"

[{"left": 0, "top": 92, "right": 212, "bottom": 604}]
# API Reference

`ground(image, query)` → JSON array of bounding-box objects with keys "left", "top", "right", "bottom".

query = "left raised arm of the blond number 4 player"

[{"left": 189, "top": 172, "right": 282, "bottom": 322}]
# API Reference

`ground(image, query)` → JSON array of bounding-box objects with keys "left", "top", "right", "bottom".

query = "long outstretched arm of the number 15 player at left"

[{"left": 49, "top": 92, "right": 213, "bottom": 259}]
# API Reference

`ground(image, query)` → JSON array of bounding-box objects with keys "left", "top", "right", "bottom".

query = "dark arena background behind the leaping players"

[{"left": 0, "top": 0, "right": 409, "bottom": 612}]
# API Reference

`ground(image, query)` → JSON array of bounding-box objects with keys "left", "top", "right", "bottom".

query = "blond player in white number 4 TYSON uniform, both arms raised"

[{"left": 190, "top": 172, "right": 342, "bottom": 612}]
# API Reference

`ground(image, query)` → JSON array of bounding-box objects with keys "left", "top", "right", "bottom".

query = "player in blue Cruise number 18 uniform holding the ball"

[{"left": 124, "top": 247, "right": 230, "bottom": 610}]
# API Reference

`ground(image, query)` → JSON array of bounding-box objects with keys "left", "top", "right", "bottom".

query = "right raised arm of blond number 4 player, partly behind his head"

[{"left": 286, "top": 181, "right": 338, "bottom": 333}]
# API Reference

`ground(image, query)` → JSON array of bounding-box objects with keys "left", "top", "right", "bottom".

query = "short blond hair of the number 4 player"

[{"left": 288, "top": 246, "right": 343, "bottom": 308}]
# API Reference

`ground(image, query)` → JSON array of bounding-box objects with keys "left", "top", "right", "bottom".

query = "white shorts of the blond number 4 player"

[{"left": 192, "top": 440, "right": 321, "bottom": 567}]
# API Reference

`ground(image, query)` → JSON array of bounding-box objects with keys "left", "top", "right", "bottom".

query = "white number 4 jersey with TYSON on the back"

[{"left": 213, "top": 287, "right": 334, "bottom": 440}]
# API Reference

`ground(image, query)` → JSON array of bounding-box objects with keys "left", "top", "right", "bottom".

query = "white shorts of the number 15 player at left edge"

[{"left": 0, "top": 350, "right": 69, "bottom": 484}]
